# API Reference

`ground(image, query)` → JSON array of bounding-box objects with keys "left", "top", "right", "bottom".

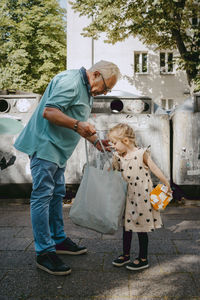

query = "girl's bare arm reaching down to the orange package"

[{"left": 143, "top": 151, "right": 171, "bottom": 192}]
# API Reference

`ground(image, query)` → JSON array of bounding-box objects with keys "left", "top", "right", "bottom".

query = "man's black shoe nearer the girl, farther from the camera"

[{"left": 56, "top": 238, "right": 87, "bottom": 255}]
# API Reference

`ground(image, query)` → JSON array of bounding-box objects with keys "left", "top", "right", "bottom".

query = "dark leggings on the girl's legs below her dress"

[{"left": 123, "top": 227, "right": 148, "bottom": 259}]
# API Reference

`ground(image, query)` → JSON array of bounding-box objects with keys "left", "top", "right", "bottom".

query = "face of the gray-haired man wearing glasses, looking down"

[{"left": 90, "top": 71, "right": 117, "bottom": 97}]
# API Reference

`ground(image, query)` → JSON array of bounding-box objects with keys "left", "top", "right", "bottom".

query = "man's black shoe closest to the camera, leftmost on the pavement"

[{"left": 36, "top": 252, "right": 72, "bottom": 275}]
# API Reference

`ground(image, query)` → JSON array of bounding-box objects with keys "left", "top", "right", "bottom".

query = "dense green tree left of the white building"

[{"left": 0, "top": 0, "right": 66, "bottom": 93}]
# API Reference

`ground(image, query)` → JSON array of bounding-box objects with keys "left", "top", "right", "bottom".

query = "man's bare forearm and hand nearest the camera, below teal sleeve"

[{"left": 43, "top": 107, "right": 96, "bottom": 142}]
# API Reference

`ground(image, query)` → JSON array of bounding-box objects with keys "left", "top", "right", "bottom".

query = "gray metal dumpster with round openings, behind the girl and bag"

[{"left": 65, "top": 91, "right": 170, "bottom": 184}]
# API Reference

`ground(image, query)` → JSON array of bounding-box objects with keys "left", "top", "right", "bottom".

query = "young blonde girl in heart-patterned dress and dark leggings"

[{"left": 108, "top": 124, "right": 170, "bottom": 270}]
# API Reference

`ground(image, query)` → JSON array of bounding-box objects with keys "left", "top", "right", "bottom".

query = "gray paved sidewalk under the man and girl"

[{"left": 0, "top": 202, "right": 200, "bottom": 300}]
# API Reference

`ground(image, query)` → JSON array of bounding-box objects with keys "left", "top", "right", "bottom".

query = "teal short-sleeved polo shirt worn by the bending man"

[{"left": 14, "top": 68, "right": 93, "bottom": 168}]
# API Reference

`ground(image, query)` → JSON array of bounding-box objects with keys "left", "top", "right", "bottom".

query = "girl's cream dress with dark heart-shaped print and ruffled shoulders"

[{"left": 113, "top": 148, "right": 162, "bottom": 232}]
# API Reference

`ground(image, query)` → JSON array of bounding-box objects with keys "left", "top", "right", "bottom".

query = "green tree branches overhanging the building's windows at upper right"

[{"left": 71, "top": 0, "right": 200, "bottom": 90}]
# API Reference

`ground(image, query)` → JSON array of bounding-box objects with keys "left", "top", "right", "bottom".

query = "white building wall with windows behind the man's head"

[{"left": 67, "top": 0, "right": 188, "bottom": 104}]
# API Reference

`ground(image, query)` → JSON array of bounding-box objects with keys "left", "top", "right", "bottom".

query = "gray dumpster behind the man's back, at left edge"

[{"left": 0, "top": 93, "right": 40, "bottom": 185}]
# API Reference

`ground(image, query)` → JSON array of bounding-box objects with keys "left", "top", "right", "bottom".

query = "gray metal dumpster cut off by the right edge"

[{"left": 172, "top": 99, "right": 200, "bottom": 186}]
